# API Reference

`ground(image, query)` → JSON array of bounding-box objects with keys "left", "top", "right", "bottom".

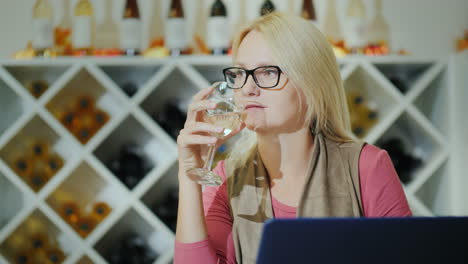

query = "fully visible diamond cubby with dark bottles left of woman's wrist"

[{"left": 94, "top": 115, "right": 176, "bottom": 192}]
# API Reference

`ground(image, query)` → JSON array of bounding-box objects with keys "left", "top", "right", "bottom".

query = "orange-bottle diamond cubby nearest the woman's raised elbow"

[{"left": 46, "top": 162, "right": 126, "bottom": 238}]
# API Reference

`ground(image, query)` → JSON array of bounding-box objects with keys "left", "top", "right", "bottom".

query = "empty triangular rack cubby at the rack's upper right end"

[{"left": 413, "top": 67, "right": 450, "bottom": 135}]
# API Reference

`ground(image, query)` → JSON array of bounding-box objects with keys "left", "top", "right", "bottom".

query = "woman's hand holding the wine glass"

[{"left": 177, "top": 83, "right": 244, "bottom": 180}]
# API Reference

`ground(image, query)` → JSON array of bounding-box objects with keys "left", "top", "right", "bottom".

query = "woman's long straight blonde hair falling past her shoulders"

[{"left": 226, "top": 12, "right": 355, "bottom": 175}]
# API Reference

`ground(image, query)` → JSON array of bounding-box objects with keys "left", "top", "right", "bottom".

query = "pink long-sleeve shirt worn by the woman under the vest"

[{"left": 174, "top": 144, "right": 411, "bottom": 264}]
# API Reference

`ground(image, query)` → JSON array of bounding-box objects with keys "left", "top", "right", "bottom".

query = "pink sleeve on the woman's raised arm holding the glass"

[{"left": 174, "top": 161, "right": 236, "bottom": 264}]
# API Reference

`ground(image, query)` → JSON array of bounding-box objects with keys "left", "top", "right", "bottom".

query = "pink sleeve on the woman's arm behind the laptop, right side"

[{"left": 359, "top": 144, "right": 412, "bottom": 217}]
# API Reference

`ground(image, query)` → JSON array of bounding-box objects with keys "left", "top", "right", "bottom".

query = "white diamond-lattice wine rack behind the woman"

[{"left": 0, "top": 55, "right": 468, "bottom": 264}]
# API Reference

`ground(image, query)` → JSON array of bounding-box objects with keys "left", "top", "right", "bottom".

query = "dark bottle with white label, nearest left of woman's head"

[{"left": 206, "top": 0, "right": 230, "bottom": 55}]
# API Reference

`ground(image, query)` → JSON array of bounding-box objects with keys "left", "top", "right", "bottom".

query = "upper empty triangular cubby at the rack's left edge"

[{"left": 0, "top": 79, "right": 31, "bottom": 139}]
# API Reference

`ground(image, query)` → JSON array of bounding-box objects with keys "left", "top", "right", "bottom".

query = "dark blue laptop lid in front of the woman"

[{"left": 257, "top": 217, "right": 468, "bottom": 264}]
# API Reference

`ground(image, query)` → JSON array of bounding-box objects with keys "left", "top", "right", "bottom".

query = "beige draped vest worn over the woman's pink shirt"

[{"left": 227, "top": 134, "right": 364, "bottom": 264}]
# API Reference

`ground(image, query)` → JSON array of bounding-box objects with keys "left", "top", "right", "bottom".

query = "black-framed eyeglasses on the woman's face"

[{"left": 223, "top": 66, "right": 282, "bottom": 89}]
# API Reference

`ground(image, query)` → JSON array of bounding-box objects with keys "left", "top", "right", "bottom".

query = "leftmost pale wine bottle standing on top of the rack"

[{"left": 32, "top": 0, "right": 54, "bottom": 56}]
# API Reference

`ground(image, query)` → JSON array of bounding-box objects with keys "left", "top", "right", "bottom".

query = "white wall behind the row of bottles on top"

[{"left": 0, "top": 0, "right": 468, "bottom": 58}]
